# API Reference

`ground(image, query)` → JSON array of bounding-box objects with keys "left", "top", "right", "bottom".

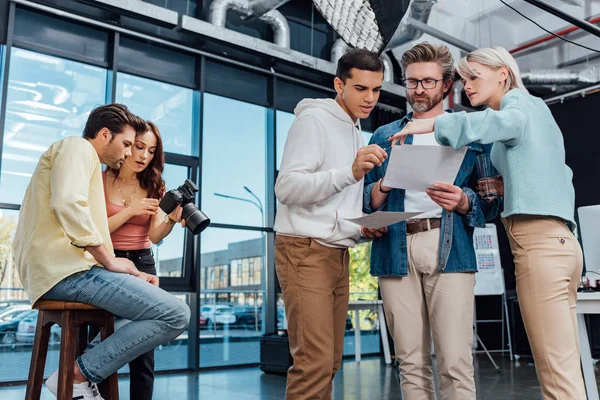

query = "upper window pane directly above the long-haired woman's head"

[{"left": 116, "top": 73, "right": 198, "bottom": 155}]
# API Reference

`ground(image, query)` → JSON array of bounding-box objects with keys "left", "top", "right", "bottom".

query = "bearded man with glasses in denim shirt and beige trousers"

[{"left": 362, "top": 43, "right": 498, "bottom": 400}]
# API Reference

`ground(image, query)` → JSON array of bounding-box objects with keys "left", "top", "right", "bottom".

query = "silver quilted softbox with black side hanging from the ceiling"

[{"left": 313, "top": 0, "right": 410, "bottom": 53}]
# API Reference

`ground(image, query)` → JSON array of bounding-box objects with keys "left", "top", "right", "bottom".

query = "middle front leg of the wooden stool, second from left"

[{"left": 58, "top": 310, "right": 77, "bottom": 400}]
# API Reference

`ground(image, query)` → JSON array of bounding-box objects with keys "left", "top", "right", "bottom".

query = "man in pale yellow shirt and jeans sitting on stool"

[{"left": 13, "top": 104, "right": 190, "bottom": 400}]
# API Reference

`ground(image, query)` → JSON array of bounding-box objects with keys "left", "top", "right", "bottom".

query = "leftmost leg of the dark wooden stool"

[{"left": 25, "top": 311, "right": 52, "bottom": 400}]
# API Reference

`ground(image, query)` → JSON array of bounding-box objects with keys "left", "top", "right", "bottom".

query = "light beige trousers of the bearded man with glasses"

[{"left": 379, "top": 229, "right": 475, "bottom": 400}]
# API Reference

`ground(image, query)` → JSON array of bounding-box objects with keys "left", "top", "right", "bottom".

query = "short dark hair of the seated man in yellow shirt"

[{"left": 83, "top": 104, "right": 147, "bottom": 139}]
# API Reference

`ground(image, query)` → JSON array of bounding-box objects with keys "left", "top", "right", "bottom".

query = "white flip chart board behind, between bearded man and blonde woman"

[{"left": 473, "top": 224, "right": 504, "bottom": 296}]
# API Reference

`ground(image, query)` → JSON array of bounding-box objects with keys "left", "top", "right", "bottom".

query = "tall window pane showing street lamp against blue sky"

[{"left": 202, "top": 94, "right": 267, "bottom": 226}]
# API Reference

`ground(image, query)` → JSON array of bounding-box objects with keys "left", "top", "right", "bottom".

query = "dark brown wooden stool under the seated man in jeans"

[{"left": 25, "top": 300, "right": 119, "bottom": 400}]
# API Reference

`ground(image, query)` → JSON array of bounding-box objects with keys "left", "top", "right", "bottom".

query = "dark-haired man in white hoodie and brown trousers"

[{"left": 275, "top": 49, "right": 387, "bottom": 400}]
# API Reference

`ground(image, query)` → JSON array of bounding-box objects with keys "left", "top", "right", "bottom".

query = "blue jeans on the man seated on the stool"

[{"left": 43, "top": 267, "right": 190, "bottom": 383}]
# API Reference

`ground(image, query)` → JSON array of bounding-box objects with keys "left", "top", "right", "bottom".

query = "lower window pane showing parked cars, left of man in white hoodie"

[{"left": 200, "top": 228, "right": 265, "bottom": 367}]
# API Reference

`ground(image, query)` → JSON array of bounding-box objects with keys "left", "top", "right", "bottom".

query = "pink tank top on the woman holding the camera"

[{"left": 102, "top": 171, "right": 152, "bottom": 250}]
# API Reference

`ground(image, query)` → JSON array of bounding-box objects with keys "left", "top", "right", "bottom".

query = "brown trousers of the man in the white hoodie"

[{"left": 275, "top": 235, "right": 349, "bottom": 400}]
